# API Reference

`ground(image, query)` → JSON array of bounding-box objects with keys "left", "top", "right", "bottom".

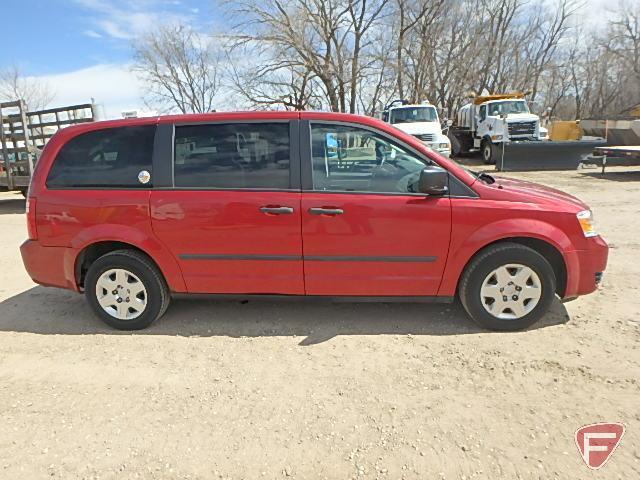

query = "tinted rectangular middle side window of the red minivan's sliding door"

[{"left": 174, "top": 122, "right": 290, "bottom": 189}]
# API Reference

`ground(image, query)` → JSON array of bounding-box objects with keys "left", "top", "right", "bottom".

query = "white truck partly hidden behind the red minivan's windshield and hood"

[{"left": 382, "top": 100, "right": 451, "bottom": 157}]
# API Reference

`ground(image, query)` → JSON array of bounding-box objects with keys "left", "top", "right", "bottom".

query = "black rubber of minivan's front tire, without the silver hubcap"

[{"left": 458, "top": 242, "right": 556, "bottom": 331}]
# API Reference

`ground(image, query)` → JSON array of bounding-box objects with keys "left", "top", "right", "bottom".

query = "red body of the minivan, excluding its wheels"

[{"left": 21, "top": 112, "right": 608, "bottom": 330}]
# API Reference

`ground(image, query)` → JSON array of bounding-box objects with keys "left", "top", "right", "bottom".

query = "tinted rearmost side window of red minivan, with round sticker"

[{"left": 47, "top": 125, "right": 156, "bottom": 188}]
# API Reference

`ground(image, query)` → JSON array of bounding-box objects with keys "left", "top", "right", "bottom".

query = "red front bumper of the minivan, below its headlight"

[{"left": 564, "top": 236, "right": 609, "bottom": 298}]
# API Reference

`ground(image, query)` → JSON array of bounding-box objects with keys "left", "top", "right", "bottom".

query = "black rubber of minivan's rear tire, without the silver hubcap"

[{"left": 84, "top": 250, "right": 171, "bottom": 330}]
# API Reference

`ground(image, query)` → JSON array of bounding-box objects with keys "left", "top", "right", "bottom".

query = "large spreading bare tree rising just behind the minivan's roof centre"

[{"left": 229, "top": 0, "right": 389, "bottom": 113}]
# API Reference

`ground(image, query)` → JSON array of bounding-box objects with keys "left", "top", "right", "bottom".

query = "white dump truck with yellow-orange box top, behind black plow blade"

[{"left": 449, "top": 93, "right": 545, "bottom": 164}]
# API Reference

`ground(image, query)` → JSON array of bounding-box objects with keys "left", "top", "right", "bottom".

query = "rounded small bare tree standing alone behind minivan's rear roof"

[{"left": 133, "top": 25, "right": 220, "bottom": 113}]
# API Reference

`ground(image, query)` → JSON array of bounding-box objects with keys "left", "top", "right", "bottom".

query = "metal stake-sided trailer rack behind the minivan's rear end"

[{"left": 0, "top": 100, "right": 96, "bottom": 192}]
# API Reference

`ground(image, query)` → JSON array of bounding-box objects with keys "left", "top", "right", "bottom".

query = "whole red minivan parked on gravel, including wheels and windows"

[{"left": 21, "top": 112, "right": 608, "bottom": 330}]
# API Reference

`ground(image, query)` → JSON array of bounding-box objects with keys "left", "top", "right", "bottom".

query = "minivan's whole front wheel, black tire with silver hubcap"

[{"left": 459, "top": 242, "right": 556, "bottom": 331}]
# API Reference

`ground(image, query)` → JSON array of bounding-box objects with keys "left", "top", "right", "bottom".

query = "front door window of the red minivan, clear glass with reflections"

[{"left": 311, "top": 124, "right": 430, "bottom": 193}]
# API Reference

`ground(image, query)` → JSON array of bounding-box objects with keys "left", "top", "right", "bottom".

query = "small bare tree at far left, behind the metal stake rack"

[{"left": 0, "top": 65, "right": 55, "bottom": 110}]
